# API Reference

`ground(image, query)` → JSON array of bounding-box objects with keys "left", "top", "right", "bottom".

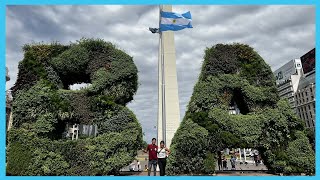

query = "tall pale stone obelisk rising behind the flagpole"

[{"left": 158, "top": 5, "right": 180, "bottom": 147}]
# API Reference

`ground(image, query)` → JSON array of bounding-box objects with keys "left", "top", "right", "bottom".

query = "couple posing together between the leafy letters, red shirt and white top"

[{"left": 144, "top": 138, "right": 170, "bottom": 176}]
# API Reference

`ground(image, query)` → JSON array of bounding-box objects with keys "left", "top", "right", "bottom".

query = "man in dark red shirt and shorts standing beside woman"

[{"left": 144, "top": 138, "right": 158, "bottom": 176}]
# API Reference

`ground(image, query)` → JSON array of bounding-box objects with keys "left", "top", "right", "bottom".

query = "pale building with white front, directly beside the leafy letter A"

[{"left": 273, "top": 59, "right": 303, "bottom": 111}]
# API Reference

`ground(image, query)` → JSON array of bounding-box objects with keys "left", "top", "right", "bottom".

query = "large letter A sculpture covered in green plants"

[{"left": 167, "top": 44, "right": 315, "bottom": 175}]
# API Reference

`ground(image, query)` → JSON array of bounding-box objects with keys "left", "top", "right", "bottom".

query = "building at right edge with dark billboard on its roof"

[{"left": 295, "top": 48, "right": 316, "bottom": 130}]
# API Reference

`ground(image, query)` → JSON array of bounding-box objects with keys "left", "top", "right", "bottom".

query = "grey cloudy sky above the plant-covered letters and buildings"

[{"left": 6, "top": 5, "right": 315, "bottom": 142}]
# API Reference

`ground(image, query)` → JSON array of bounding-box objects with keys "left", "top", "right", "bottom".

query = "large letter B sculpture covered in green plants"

[{"left": 7, "top": 39, "right": 142, "bottom": 175}]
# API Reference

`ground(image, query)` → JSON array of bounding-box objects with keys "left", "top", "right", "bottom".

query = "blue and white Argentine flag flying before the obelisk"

[{"left": 160, "top": 11, "right": 192, "bottom": 32}]
